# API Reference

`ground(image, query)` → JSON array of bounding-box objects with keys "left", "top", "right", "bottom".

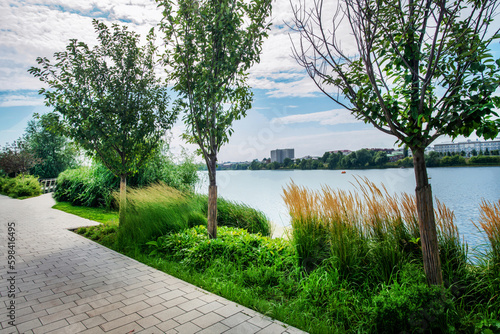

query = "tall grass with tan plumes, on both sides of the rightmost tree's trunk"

[{"left": 283, "top": 178, "right": 467, "bottom": 281}]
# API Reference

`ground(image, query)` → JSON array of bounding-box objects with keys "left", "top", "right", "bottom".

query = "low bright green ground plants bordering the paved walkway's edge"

[{"left": 71, "top": 200, "right": 500, "bottom": 334}]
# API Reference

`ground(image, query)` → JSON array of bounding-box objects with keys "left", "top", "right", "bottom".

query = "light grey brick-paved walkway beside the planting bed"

[{"left": 0, "top": 194, "right": 303, "bottom": 334}]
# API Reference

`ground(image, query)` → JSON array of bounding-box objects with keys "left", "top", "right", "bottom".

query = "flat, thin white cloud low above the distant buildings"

[{"left": 274, "top": 109, "right": 362, "bottom": 125}]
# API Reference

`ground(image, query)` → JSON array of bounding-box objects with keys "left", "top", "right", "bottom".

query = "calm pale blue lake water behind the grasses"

[{"left": 197, "top": 167, "right": 500, "bottom": 247}]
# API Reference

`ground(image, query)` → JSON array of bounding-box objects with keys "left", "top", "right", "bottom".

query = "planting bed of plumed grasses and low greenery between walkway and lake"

[{"left": 52, "top": 179, "right": 500, "bottom": 333}]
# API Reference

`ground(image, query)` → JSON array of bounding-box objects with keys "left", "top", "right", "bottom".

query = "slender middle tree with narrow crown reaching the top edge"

[{"left": 157, "top": 0, "right": 271, "bottom": 238}]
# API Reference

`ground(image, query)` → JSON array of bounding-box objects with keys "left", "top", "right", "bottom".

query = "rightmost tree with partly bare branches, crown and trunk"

[{"left": 293, "top": 0, "right": 500, "bottom": 285}]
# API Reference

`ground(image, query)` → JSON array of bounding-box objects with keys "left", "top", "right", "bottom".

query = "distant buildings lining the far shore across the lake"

[{"left": 219, "top": 140, "right": 500, "bottom": 169}]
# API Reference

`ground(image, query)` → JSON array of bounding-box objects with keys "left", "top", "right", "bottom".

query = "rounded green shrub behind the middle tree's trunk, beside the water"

[{"left": 196, "top": 195, "right": 272, "bottom": 236}]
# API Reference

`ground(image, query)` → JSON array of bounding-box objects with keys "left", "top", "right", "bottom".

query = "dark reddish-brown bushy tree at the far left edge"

[{"left": 0, "top": 138, "right": 42, "bottom": 176}]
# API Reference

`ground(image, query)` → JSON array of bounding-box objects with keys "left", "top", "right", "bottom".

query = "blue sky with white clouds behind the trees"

[{"left": 0, "top": 0, "right": 496, "bottom": 162}]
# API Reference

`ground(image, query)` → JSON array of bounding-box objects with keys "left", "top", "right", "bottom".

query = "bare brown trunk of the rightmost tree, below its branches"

[{"left": 412, "top": 148, "right": 443, "bottom": 285}]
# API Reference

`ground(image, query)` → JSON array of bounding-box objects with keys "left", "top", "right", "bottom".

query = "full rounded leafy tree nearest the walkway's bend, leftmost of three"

[{"left": 29, "top": 20, "right": 176, "bottom": 235}]
